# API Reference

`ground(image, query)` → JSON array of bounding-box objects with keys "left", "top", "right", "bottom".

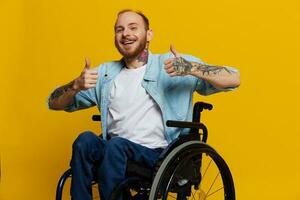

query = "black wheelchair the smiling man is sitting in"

[{"left": 56, "top": 102, "right": 235, "bottom": 200}]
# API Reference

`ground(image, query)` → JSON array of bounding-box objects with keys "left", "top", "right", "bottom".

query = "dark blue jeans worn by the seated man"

[{"left": 70, "top": 131, "right": 159, "bottom": 200}]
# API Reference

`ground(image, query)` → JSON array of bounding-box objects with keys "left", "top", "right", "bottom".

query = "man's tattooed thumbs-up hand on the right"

[{"left": 164, "top": 45, "right": 192, "bottom": 77}]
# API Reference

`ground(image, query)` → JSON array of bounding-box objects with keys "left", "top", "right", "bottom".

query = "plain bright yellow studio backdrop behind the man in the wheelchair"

[{"left": 0, "top": 0, "right": 300, "bottom": 200}]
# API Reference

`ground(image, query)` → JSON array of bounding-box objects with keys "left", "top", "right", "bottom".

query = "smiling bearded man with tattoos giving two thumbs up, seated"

[{"left": 49, "top": 10, "right": 240, "bottom": 200}]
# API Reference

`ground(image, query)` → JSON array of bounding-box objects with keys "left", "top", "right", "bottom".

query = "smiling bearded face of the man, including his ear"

[{"left": 115, "top": 12, "right": 152, "bottom": 58}]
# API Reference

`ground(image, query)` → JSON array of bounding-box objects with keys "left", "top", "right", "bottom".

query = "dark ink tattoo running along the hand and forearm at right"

[{"left": 173, "top": 57, "right": 233, "bottom": 76}]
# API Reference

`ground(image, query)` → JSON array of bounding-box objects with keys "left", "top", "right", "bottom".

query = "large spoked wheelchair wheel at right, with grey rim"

[{"left": 149, "top": 141, "right": 235, "bottom": 200}]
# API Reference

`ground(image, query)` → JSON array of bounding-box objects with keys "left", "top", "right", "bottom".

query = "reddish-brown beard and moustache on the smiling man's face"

[{"left": 115, "top": 36, "right": 147, "bottom": 59}]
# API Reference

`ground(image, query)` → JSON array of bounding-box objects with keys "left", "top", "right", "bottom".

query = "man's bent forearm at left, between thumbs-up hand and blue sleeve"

[{"left": 48, "top": 81, "right": 79, "bottom": 110}]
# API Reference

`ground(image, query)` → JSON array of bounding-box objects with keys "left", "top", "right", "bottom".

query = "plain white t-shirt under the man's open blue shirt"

[{"left": 107, "top": 65, "right": 168, "bottom": 148}]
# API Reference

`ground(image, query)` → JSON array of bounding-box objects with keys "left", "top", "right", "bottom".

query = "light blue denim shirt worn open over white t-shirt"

[{"left": 65, "top": 52, "right": 232, "bottom": 143}]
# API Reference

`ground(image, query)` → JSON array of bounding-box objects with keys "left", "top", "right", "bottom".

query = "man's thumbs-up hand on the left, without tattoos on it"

[{"left": 73, "top": 58, "right": 98, "bottom": 91}]
